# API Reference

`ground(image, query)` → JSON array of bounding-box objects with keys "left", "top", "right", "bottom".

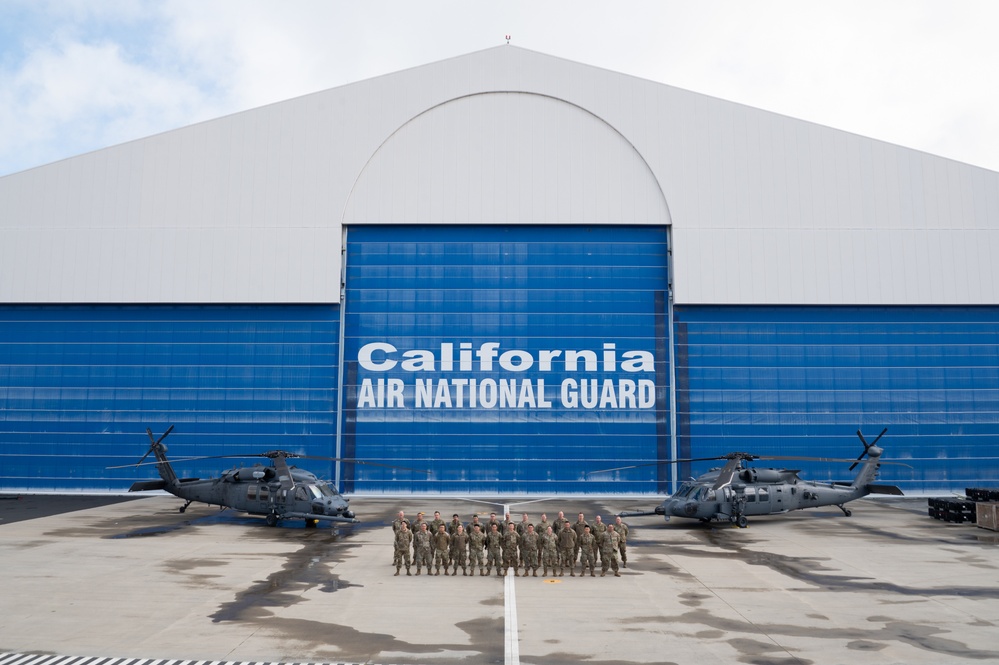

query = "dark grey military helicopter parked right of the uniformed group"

[{"left": 608, "top": 427, "right": 911, "bottom": 529}]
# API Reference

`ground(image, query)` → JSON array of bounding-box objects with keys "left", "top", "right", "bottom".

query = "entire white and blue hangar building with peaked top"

[{"left": 0, "top": 45, "right": 999, "bottom": 494}]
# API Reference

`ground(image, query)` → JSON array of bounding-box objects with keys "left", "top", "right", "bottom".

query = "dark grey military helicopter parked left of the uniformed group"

[{"left": 108, "top": 425, "right": 416, "bottom": 527}]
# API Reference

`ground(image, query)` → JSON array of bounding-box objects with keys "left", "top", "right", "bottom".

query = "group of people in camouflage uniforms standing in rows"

[{"left": 392, "top": 510, "right": 628, "bottom": 577}]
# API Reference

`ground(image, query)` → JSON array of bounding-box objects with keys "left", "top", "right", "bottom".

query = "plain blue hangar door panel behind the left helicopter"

[{"left": 0, "top": 306, "right": 339, "bottom": 490}]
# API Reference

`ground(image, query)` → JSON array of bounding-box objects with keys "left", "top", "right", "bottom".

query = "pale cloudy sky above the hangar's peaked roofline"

[{"left": 0, "top": 0, "right": 999, "bottom": 176}]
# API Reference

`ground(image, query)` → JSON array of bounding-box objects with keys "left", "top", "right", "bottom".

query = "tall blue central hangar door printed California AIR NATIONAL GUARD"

[{"left": 340, "top": 226, "right": 670, "bottom": 494}]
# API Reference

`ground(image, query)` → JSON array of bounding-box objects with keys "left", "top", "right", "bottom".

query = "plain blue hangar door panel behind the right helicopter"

[{"left": 674, "top": 306, "right": 999, "bottom": 491}]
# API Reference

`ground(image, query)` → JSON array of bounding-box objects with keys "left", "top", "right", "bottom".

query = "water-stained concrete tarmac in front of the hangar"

[{"left": 0, "top": 496, "right": 999, "bottom": 665}]
